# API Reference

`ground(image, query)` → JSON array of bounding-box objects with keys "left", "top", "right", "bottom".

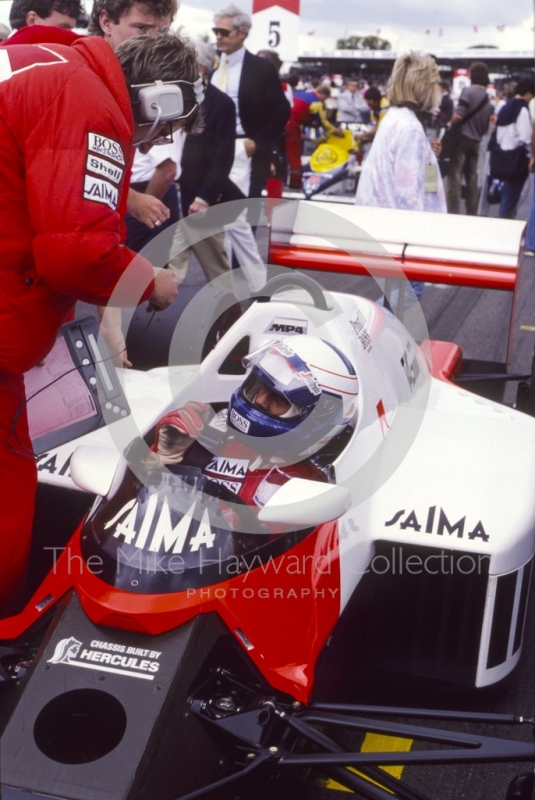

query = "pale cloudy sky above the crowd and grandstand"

[{"left": 0, "top": 0, "right": 535, "bottom": 53}]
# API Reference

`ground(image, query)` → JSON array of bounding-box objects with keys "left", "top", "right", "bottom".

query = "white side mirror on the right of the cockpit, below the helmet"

[{"left": 258, "top": 478, "right": 351, "bottom": 528}]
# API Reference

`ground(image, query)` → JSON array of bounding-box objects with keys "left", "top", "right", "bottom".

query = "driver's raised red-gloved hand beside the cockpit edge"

[{"left": 151, "top": 400, "right": 212, "bottom": 464}]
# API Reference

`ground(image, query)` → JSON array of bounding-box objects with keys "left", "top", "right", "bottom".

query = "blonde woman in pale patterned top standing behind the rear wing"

[{"left": 355, "top": 52, "right": 446, "bottom": 305}]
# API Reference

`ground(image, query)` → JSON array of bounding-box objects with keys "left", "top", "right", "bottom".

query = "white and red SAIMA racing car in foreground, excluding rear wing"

[{"left": 0, "top": 275, "right": 535, "bottom": 800}]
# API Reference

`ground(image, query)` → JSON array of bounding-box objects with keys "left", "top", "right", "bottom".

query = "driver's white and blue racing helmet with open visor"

[{"left": 228, "top": 335, "right": 358, "bottom": 460}]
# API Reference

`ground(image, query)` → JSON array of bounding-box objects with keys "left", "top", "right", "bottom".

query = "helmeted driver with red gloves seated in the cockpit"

[{"left": 147, "top": 334, "right": 358, "bottom": 506}]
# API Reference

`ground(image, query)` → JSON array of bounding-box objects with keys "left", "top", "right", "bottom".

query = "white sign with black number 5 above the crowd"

[{"left": 247, "top": 0, "right": 299, "bottom": 61}]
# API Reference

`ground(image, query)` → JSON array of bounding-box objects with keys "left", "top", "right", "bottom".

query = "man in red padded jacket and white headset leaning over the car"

[{"left": 0, "top": 36, "right": 201, "bottom": 615}]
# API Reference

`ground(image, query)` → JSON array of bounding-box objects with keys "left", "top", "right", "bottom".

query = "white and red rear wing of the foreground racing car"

[{"left": 269, "top": 201, "right": 527, "bottom": 372}]
